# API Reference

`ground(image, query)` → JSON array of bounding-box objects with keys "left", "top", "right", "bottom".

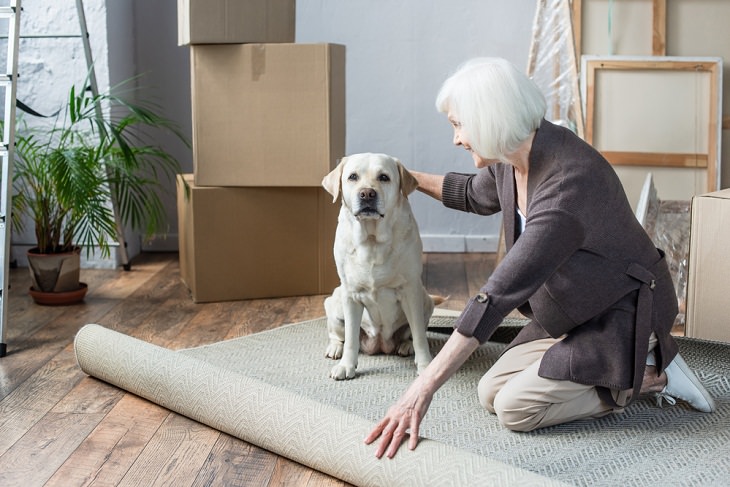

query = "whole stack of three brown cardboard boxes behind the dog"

[{"left": 178, "top": 0, "right": 345, "bottom": 302}]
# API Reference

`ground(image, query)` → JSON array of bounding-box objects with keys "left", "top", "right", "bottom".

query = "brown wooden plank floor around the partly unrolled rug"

[{"left": 0, "top": 253, "right": 495, "bottom": 487}]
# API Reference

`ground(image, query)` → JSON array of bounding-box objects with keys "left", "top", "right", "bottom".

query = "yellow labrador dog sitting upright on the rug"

[{"left": 322, "top": 153, "right": 434, "bottom": 380}]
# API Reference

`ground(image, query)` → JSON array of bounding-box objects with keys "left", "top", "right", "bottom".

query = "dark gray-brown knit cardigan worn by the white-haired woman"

[{"left": 442, "top": 120, "right": 677, "bottom": 390}]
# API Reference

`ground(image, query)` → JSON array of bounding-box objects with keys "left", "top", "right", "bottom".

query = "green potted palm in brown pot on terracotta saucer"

[{"left": 13, "top": 77, "right": 189, "bottom": 304}]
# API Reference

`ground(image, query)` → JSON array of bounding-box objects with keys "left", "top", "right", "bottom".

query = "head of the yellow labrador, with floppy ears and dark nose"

[{"left": 322, "top": 153, "right": 418, "bottom": 220}]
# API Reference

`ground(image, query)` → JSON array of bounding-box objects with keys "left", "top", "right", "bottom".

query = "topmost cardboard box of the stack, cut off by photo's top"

[{"left": 177, "top": 0, "right": 296, "bottom": 46}]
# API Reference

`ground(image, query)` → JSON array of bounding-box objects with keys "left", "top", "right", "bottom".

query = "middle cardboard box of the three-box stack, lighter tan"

[{"left": 191, "top": 44, "right": 345, "bottom": 187}]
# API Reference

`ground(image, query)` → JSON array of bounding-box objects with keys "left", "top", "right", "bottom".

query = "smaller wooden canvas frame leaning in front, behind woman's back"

[{"left": 581, "top": 56, "right": 722, "bottom": 191}]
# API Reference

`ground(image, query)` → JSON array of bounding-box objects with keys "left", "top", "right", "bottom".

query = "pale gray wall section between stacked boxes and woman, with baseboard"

[{"left": 297, "top": 0, "right": 535, "bottom": 252}]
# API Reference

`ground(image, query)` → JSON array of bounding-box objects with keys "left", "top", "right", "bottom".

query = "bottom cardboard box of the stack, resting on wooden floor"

[{"left": 177, "top": 174, "right": 340, "bottom": 302}]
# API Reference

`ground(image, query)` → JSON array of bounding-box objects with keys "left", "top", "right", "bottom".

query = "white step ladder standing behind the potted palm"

[{"left": 0, "top": 0, "right": 130, "bottom": 357}]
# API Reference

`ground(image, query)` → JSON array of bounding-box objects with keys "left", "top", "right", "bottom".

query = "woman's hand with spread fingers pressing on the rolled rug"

[{"left": 365, "top": 379, "right": 433, "bottom": 458}]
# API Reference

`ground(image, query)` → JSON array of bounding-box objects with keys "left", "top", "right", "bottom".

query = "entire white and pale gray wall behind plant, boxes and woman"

[{"left": 5, "top": 0, "right": 535, "bottom": 260}]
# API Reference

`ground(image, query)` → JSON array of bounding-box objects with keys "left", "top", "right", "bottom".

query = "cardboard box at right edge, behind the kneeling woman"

[{"left": 686, "top": 189, "right": 730, "bottom": 342}]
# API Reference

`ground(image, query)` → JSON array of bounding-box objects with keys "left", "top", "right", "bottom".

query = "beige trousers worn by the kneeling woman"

[{"left": 478, "top": 333, "right": 657, "bottom": 431}]
